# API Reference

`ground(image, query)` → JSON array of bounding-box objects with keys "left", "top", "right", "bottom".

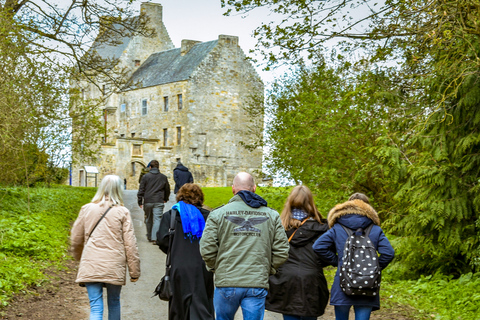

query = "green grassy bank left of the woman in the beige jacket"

[{"left": 0, "top": 186, "right": 95, "bottom": 306}]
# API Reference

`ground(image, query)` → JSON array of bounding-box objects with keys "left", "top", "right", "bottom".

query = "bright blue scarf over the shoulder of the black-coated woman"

[{"left": 172, "top": 201, "right": 205, "bottom": 242}]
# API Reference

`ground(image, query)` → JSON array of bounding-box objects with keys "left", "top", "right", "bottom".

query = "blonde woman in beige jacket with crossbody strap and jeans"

[{"left": 71, "top": 175, "right": 140, "bottom": 320}]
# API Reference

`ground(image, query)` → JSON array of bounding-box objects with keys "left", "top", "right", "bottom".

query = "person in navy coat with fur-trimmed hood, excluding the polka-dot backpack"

[{"left": 313, "top": 193, "right": 394, "bottom": 320}]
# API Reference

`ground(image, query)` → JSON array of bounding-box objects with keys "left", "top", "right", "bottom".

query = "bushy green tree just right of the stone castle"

[{"left": 266, "top": 58, "right": 392, "bottom": 213}]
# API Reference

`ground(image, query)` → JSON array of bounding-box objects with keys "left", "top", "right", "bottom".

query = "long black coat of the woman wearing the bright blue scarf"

[{"left": 157, "top": 208, "right": 215, "bottom": 320}]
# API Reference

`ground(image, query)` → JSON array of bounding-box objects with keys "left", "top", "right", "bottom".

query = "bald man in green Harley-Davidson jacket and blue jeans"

[{"left": 200, "top": 172, "right": 289, "bottom": 320}]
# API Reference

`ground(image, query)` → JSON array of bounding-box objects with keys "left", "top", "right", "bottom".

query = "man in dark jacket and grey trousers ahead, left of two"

[{"left": 137, "top": 160, "right": 170, "bottom": 244}]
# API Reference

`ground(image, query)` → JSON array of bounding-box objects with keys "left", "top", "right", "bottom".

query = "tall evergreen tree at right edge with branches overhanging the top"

[{"left": 230, "top": 0, "right": 480, "bottom": 276}]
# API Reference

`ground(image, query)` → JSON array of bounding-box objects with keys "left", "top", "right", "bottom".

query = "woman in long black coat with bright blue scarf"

[{"left": 157, "top": 183, "right": 215, "bottom": 320}]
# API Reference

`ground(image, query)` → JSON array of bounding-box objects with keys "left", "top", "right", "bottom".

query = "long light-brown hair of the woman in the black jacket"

[{"left": 280, "top": 186, "right": 323, "bottom": 230}]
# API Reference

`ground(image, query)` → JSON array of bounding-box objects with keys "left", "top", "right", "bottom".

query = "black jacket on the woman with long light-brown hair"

[{"left": 266, "top": 219, "right": 328, "bottom": 317}]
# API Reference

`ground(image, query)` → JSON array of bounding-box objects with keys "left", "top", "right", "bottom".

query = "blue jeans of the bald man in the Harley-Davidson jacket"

[{"left": 213, "top": 287, "right": 267, "bottom": 320}]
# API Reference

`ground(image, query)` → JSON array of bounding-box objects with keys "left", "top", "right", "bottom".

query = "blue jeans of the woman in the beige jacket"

[{"left": 85, "top": 282, "right": 122, "bottom": 320}]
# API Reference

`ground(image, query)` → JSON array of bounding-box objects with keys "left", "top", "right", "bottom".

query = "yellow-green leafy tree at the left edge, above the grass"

[{"left": 0, "top": 9, "right": 99, "bottom": 185}]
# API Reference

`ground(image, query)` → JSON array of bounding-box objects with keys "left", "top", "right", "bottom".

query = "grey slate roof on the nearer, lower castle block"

[{"left": 124, "top": 40, "right": 218, "bottom": 91}]
